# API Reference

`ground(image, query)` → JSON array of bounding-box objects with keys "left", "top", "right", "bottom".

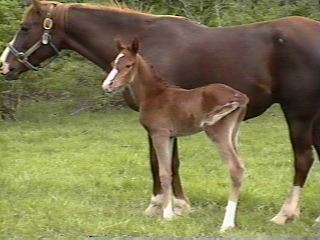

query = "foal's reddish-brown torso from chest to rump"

[{"left": 140, "top": 84, "right": 249, "bottom": 136}]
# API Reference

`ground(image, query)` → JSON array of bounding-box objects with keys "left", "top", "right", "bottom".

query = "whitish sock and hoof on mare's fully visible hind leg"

[{"left": 271, "top": 186, "right": 302, "bottom": 225}]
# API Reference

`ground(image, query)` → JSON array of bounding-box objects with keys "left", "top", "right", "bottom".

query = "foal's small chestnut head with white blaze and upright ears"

[{"left": 102, "top": 38, "right": 139, "bottom": 93}]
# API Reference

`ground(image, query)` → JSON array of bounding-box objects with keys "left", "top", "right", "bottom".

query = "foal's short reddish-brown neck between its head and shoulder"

[{"left": 133, "top": 54, "right": 169, "bottom": 103}]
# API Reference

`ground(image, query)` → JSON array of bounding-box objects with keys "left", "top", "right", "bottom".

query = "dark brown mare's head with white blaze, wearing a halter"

[{"left": 0, "top": 0, "right": 63, "bottom": 80}]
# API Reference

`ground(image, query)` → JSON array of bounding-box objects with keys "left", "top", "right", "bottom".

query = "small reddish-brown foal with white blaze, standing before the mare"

[{"left": 102, "top": 39, "right": 249, "bottom": 231}]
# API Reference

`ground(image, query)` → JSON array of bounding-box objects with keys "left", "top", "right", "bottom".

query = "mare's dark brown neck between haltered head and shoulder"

[{"left": 61, "top": 4, "right": 155, "bottom": 70}]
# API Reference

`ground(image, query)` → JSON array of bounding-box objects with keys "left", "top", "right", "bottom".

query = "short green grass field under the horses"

[{"left": 0, "top": 102, "right": 320, "bottom": 239}]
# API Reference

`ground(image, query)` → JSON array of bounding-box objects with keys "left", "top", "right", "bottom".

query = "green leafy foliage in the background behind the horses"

[{"left": 0, "top": 0, "right": 320, "bottom": 119}]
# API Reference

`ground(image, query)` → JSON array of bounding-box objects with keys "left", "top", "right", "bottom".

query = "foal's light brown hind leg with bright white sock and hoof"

[{"left": 204, "top": 108, "right": 245, "bottom": 232}]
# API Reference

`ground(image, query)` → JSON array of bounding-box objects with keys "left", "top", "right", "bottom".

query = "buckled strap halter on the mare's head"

[{"left": 8, "top": 5, "right": 60, "bottom": 71}]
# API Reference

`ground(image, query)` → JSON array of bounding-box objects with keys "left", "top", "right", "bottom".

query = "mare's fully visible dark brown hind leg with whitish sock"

[{"left": 271, "top": 104, "right": 316, "bottom": 225}]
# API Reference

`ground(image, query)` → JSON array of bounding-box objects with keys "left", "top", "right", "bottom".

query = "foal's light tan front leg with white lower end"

[{"left": 151, "top": 133, "right": 174, "bottom": 220}]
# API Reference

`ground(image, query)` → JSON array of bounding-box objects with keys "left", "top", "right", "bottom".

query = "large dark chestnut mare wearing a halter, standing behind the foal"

[{"left": 1, "top": 0, "right": 320, "bottom": 224}]
